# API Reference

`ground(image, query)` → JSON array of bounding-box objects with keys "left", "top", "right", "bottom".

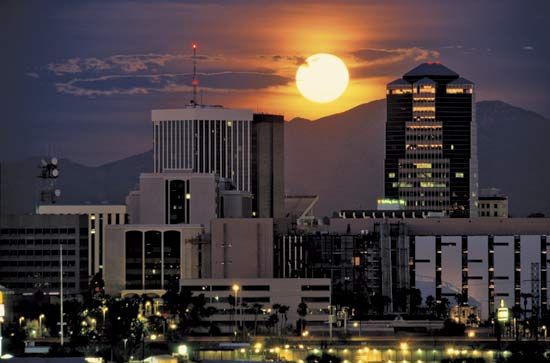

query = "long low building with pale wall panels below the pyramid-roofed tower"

[{"left": 302, "top": 216, "right": 550, "bottom": 320}]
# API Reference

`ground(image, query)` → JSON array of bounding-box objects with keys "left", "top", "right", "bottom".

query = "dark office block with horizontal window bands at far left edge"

[{"left": 0, "top": 215, "right": 88, "bottom": 297}]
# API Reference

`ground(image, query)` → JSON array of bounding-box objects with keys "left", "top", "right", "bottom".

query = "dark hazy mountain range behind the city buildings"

[{"left": 0, "top": 100, "right": 550, "bottom": 216}]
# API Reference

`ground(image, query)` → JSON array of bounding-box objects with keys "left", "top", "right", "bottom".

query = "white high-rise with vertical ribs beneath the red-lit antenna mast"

[{"left": 152, "top": 105, "right": 252, "bottom": 192}]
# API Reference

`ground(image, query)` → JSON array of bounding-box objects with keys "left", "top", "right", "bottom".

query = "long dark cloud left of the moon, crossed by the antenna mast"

[{"left": 55, "top": 71, "right": 291, "bottom": 97}]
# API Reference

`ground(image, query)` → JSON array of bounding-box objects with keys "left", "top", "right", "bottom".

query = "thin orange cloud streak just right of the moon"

[{"left": 352, "top": 47, "right": 440, "bottom": 65}]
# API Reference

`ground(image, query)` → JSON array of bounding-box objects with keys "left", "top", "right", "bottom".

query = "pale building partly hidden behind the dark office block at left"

[{"left": 37, "top": 204, "right": 127, "bottom": 276}]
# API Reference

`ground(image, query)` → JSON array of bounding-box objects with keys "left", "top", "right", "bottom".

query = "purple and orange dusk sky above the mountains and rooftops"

[{"left": 0, "top": 0, "right": 550, "bottom": 165}]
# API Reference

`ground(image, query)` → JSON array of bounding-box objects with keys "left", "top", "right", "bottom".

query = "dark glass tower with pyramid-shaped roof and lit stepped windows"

[{"left": 384, "top": 63, "right": 478, "bottom": 217}]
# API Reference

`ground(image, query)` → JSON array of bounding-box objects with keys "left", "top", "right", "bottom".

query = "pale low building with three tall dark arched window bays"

[{"left": 103, "top": 224, "right": 210, "bottom": 297}]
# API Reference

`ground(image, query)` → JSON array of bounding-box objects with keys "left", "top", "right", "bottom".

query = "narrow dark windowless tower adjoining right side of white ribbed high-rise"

[{"left": 251, "top": 114, "right": 285, "bottom": 218}]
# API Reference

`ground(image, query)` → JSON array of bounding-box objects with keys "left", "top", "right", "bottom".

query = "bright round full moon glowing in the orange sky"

[{"left": 296, "top": 53, "right": 349, "bottom": 103}]
